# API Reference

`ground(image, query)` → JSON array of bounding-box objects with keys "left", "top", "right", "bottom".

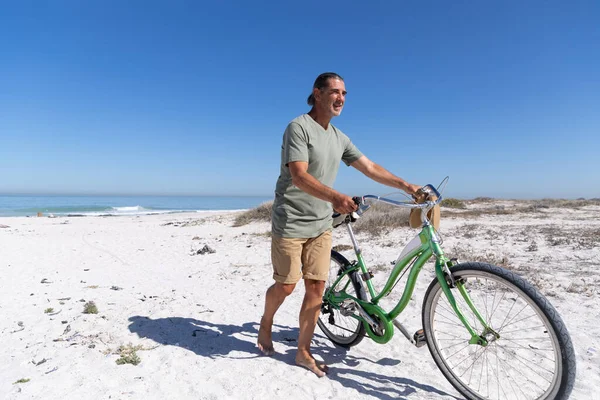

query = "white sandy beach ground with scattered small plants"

[{"left": 0, "top": 207, "right": 600, "bottom": 399}]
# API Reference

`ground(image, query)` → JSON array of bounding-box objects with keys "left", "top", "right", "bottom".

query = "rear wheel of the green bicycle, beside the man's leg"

[{"left": 317, "top": 250, "right": 367, "bottom": 348}]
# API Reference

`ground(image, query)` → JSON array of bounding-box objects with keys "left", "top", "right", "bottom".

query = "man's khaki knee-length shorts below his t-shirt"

[{"left": 271, "top": 231, "right": 331, "bottom": 283}]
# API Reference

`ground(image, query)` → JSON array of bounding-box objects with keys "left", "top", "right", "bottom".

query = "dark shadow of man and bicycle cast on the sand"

[{"left": 129, "top": 316, "right": 459, "bottom": 399}]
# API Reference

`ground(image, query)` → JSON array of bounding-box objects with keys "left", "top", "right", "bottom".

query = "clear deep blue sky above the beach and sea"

[{"left": 0, "top": 0, "right": 600, "bottom": 198}]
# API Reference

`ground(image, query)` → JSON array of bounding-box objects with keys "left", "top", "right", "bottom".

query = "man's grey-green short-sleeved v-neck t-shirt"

[{"left": 272, "top": 114, "right": 362, "bottom": 238}]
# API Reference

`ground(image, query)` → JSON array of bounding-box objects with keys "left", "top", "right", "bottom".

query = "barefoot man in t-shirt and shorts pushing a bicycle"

[{"left": 257, "top": 72, "right": 419, "bottom": 377}]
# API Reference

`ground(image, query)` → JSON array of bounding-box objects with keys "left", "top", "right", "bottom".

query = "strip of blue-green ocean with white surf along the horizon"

[{"left": 0, "top": 195, "right": 273, "bottom": 217}]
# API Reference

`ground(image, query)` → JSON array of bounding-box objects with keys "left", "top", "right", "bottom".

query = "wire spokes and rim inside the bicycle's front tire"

[{"left": 424, "top": 266, "right": 572, "bottom": 400}]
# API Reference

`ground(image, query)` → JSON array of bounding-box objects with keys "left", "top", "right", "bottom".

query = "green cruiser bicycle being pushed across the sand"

[{"left": 318, "top": 185, "right": 576, "bottom": 399}]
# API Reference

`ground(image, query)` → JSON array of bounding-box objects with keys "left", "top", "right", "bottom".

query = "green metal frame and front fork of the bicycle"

[{"left": 325, "top": 195, "right": 498, "bottom": 346}]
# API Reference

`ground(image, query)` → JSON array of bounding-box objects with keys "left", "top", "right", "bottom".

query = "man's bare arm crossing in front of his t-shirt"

[{"left": 288, "top": 161, "right": 356, "bottom": 214}]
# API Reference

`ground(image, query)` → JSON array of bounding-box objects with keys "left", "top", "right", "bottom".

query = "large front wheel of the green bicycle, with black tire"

[{"left": 423, "top": 263, "right": 576, "bottom": 400}]
